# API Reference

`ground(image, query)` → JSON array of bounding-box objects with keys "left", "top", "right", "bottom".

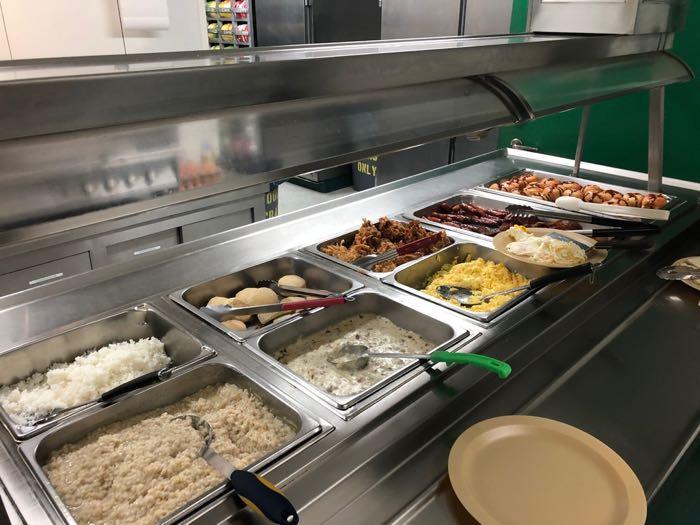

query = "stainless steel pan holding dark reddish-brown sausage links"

[{"left": 405, "top": 190, "right": 601, "bottom": 241}]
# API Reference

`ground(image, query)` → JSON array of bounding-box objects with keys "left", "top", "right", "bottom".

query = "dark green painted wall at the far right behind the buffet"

[{"left": 501, "top": 0, "right": 700, "bottom": 182}]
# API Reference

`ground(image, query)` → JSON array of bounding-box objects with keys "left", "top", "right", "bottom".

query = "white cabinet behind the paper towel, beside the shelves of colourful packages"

[{"left": 124, "top": 0, "right": 209, "bottom": 54}]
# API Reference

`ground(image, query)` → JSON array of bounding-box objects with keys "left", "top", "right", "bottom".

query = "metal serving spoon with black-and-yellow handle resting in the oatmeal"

[{"left": 173, "top": 414, "right": 299, "bottom": 525}]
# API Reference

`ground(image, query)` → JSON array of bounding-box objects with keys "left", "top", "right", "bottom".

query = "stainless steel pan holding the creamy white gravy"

[{"left": 248, "top": 290, "right": 470, "bottom": 410}]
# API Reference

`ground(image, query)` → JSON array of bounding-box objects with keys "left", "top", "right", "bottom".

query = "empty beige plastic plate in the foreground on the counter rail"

[{"left": 449, "top": 416, "right": 647, "bottom": 525}]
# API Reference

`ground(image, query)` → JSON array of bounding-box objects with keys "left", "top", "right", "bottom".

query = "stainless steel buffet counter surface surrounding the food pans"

[{"left": 0, "top": 151, "right": 700, "bottom": 524}]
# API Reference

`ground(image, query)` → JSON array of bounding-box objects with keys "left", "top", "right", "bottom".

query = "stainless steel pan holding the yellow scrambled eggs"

[{"left": 383, "top": 243, "right": 552, "bottom": 322}]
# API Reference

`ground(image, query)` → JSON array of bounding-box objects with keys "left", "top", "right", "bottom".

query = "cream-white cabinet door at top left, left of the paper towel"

[{"left": 0, "top": 0, "right": 124, "bottom": 59}]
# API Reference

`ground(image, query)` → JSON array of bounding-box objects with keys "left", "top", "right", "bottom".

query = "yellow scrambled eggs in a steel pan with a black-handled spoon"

[{"left": 422, "top": 257, "right": 528, "bottom": 312}]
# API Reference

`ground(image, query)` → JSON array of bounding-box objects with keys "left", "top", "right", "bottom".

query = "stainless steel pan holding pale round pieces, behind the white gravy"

[{"left": 170, "top": 254, "right": 362, "bottom": 341}]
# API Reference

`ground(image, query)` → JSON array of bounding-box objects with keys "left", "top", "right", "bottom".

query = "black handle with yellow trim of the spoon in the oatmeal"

[{"left": 229, "top": 470, "right": 299, "bottom": 525}]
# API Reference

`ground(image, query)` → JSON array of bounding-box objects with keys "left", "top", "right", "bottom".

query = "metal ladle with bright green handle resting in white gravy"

[{"left": 326, "top": 345, "right": 512, "bottom": 379}]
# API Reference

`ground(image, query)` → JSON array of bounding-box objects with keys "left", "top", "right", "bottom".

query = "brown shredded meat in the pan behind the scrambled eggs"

[{"left": 321, "top": 217, "right": 451, "bottom": 272}]
